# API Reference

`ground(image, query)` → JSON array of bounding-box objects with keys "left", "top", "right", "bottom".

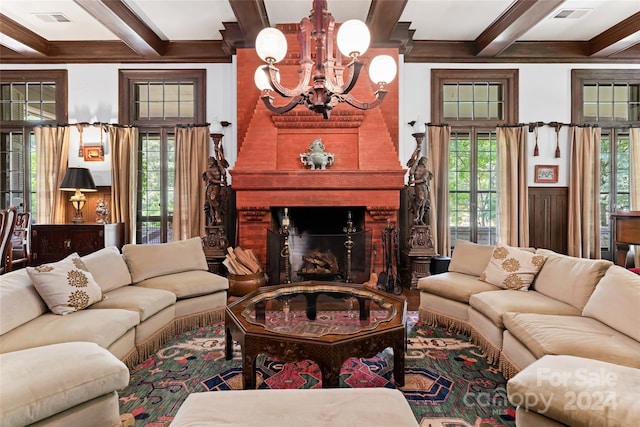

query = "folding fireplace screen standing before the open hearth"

[{"left": 266, "top": 230, "right": 372, "bottom": 285}]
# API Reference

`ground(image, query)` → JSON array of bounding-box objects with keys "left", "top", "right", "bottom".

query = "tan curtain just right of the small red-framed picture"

[{"left": 568, "top": 126, "right": 601, "bottom": 259}]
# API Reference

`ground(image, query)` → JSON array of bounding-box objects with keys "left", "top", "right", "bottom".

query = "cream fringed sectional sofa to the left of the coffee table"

[{"left": 0, "top": 238, "right": 228, "bottom": 426}]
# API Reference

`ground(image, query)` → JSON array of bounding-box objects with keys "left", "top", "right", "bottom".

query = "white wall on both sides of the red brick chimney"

[{"left": 0, "top": 60, "right": 640, "bottom": 186}]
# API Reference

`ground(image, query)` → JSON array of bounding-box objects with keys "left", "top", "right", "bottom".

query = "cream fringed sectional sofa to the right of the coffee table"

[{"left": 418, "top": 241, "right": 640, "bottom": 425}]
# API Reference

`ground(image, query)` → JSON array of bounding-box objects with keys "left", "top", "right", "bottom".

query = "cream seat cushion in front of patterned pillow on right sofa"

[{"left": 469, "top": 290, "right": 580, "bottom": 328}]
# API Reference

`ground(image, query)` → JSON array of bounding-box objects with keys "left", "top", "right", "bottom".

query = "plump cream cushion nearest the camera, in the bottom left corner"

[{"left": 0, "top": 342, "right": 129, "bottom": 427}]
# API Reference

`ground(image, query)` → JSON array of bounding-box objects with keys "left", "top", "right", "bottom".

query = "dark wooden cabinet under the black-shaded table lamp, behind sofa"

[{"left": 31, "top": 223, "right": 124, "bottom": 265}]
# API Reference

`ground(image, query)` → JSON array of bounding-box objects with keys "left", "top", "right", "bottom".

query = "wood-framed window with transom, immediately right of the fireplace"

[{"left": 431, "top": 69, "right": 518, "bottom": 247}]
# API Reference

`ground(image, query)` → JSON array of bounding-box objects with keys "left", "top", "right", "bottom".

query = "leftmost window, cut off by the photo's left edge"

[{"left": 0, "top": 70, "right": 67, "bottom": 216}]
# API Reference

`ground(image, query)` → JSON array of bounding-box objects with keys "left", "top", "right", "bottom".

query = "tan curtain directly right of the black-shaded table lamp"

[{"left": 109, "top": 126, "right": 138, "bottom": 243}]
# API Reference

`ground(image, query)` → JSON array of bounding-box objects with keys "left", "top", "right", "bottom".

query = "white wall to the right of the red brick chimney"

[{"left": 399, "top": 63, "right": 640, "bottom": 187}]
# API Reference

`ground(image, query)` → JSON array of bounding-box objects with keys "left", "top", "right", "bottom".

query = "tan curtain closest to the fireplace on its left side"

[{"left": 173, "top": 126, "right": 209, "bottom": 240}]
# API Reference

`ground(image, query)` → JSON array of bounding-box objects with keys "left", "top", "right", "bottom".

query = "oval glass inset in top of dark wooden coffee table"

[{"left": 242, "top": 285, "right": 396, "bottom": 337}]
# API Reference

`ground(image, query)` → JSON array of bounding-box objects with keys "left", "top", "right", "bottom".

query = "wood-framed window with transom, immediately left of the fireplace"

[{"left": 120, "top": 70, "right": 205, "bottom": 243}]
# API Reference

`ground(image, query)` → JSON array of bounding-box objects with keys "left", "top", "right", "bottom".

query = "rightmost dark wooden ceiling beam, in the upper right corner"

[{"left": 589, "top": 12, "right": 640, "bottom": 57}]
